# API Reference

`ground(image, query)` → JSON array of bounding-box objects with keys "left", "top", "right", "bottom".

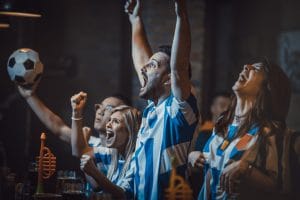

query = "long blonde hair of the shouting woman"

[{"left": 107, "top": 105, "right": 141, "bottom": 179}]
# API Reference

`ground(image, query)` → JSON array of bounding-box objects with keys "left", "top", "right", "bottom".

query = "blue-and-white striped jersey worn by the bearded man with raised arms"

[{"left": 118, "top": 95, "right": 198, "bottom": 199}]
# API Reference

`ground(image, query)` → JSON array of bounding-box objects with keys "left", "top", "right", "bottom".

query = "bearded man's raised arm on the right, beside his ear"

[{"left": 170, "top": 0, "right": 191, "bottom": 100}]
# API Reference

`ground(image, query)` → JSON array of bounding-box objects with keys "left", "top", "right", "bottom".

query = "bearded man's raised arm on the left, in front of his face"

[{"left": 125, "top": 0, "right": 152, "bottom": 84}]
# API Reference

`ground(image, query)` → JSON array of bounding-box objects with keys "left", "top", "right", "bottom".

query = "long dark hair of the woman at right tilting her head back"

[{"left": 215, "top": 59, "right": 291, "bottom": 137}]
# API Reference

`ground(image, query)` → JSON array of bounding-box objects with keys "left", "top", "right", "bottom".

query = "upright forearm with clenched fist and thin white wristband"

[{"left": 71, "top": 92, "right": 93, "bottom": 157}]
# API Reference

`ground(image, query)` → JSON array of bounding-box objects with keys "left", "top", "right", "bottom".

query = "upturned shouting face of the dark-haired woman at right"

[{"left": 232, "top": 63, "right": 265, "bottom": 96}]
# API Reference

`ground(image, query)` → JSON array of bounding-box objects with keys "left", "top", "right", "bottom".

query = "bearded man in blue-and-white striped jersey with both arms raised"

[{"left": 118, "top": 0, "right": 198, "bottom": 199}]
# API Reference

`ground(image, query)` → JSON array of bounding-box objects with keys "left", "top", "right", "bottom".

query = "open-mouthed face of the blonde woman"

[{"left": 106, "top": 111, "right": 129, "bottom": 152}]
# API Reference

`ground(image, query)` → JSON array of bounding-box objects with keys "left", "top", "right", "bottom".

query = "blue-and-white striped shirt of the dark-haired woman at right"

[{"left": 198, "top": 124, "right": 278, "bottom": 200}]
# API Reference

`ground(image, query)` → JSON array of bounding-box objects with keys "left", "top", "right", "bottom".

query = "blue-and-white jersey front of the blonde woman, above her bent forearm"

[{"left": 93, "top": 146, "right": 125, "bottom": 184}]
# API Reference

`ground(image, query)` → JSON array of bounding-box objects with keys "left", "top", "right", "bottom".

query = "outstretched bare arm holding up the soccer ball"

[{"left": 18, "top": 83, "right": 71, "bottom": 144}]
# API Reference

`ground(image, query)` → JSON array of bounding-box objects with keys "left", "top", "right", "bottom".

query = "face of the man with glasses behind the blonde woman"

[{"left": 94, "top": 97, "right": 123, "bottom": 133}]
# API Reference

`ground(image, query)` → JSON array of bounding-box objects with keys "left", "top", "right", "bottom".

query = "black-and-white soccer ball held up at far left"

[{"left": 7, "top": 48, "right": 44, "bottom": 88}]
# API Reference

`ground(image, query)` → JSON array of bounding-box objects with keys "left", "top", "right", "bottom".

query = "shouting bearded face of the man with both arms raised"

[{"left": 139, "top": 52, "right": 170, "bottom": 99}]
